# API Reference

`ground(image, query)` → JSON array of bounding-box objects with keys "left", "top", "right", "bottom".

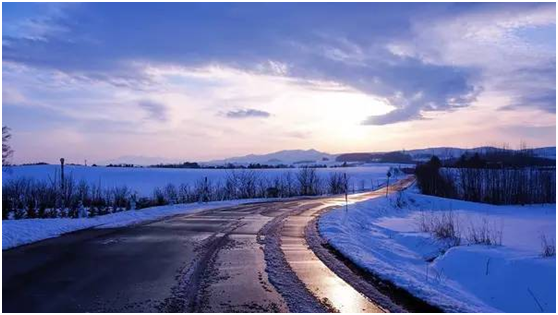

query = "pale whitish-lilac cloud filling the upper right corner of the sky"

[{"left": 388, "top": 4, "right": 556, "bottom": 113}]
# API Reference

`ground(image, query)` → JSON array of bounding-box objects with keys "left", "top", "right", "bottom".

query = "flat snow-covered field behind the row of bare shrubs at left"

[{"left": 2, "top": 164, "right": 398, "bottom": 196}]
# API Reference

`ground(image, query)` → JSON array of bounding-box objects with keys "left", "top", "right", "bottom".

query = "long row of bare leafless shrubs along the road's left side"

[{"left": 2, "top": 167, "right": 354, "bottom": 219}]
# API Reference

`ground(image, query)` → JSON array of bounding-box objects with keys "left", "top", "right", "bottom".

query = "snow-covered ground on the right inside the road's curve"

[{"left": 319, "top": 191, "right": 556, "bottom": 312}]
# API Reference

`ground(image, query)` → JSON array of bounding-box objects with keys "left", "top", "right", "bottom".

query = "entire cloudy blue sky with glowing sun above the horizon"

[{"left": 2, "top": 3, "right": 556, "bottom": 163}]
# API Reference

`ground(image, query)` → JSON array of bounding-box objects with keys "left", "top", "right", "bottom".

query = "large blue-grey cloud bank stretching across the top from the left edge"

[{"left": 3, "top": 4, "right": 492, "bottom": 127}]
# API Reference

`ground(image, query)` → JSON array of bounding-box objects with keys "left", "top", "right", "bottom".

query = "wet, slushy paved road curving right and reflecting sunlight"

[{"left": 2, "top": 179, "right": 416, "bottom": 312}]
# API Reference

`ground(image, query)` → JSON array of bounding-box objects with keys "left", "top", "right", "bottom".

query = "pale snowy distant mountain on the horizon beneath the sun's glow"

[{"left": 203, "top": 149, "right": 335, "bottom": 165}]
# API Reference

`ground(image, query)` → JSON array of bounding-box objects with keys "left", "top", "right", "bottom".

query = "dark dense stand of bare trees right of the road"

[{"left": 415, "top": 152, "right": 556, "bottom": 205}]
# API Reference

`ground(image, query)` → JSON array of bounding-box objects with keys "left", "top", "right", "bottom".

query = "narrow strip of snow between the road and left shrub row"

[{"left": 2, "top": 199, "right": 269, "bottom": 250}]
